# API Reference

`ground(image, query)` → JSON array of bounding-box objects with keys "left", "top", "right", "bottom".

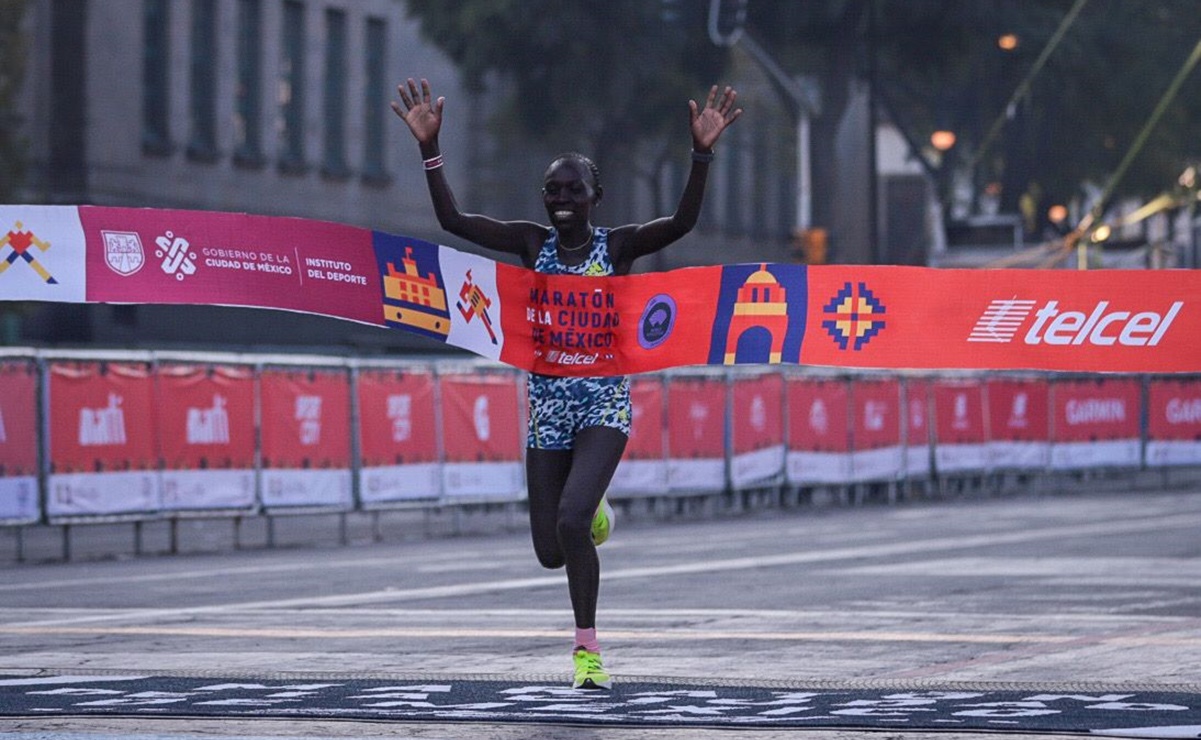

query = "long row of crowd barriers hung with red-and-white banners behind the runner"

[{"left": 0, "top": 348, "right": 1201, "bottom": 555}]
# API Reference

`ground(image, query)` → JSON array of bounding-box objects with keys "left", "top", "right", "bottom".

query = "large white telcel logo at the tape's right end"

[{"left": 968, "top": 299, "right": 1184, "bottom": 347}]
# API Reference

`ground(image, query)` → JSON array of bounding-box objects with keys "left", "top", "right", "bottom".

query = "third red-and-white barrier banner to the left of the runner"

[{"left": 259, "top": 368, "right": 352, "bottom": 507}]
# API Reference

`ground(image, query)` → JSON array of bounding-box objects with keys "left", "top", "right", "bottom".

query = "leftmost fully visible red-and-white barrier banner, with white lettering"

[{"left": 46, "top": 362, "right": 160, "bottom": 518}]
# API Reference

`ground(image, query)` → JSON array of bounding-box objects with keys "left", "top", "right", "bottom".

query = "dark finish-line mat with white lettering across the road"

[{"left": 0, "top": 674, "right": 1201, "bottom": 738}]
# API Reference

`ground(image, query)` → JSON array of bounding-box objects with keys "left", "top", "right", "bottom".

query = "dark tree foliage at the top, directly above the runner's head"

[{"left": 408, "top": 0, "right": 725, "bottom": 164}]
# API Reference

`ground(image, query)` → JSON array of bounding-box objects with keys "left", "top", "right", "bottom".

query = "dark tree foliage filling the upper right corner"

[{"left": 749, "top": 0, "right": 1201, "bottom": 210}]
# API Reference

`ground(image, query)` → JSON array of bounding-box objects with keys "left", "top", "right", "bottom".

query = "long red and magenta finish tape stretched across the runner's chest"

[{"left": 0, "top": 205, "right": 1201, "bottom": 376}]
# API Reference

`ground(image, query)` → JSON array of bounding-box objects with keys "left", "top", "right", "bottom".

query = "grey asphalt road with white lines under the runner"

[{"left": 0, "top": 491, "right": 1201, "bottom": 740}]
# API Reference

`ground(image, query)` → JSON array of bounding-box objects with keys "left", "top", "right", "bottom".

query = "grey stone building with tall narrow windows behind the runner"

[{"left": 18, "top": 0, "right": 845, "bottom": 353}]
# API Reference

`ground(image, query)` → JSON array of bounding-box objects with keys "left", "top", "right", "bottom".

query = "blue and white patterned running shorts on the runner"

[{"left": 526, "top": 374, "right": 632, "bottom": 449}]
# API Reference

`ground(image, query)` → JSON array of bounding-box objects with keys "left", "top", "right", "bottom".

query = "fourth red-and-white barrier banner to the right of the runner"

[{"left": 785, "top": 377, "right": 852, "bottom": 485}]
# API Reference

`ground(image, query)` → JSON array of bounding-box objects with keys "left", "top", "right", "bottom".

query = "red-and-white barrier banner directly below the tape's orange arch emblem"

[{"left": 730, "top": 372, "right": 784, "bottom": 488}]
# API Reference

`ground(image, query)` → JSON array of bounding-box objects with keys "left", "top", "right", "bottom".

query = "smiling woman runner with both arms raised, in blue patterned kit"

[{"left": 392, "top": 78, "right": 742, "bottom": 688}]
